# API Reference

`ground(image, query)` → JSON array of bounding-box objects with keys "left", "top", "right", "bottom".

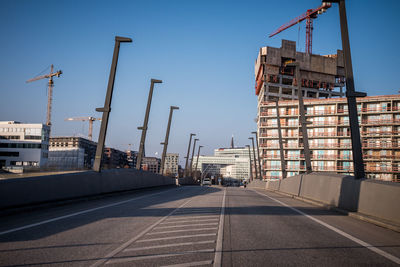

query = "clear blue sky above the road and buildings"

[{"left": 0, "top": 0, "right": 400, "bottom": 166}]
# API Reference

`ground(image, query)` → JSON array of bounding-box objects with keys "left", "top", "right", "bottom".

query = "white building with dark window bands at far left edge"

[{"left": 0, "top": 121, "right": 50, "bottom": 170}]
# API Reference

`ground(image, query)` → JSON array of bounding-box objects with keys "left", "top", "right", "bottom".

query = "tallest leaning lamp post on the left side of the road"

[{"left": 93, "top": 36, "right": 132, "bottom": 172}]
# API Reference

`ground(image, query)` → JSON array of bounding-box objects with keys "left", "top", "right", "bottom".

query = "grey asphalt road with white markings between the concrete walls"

[{"left": 0, "top": 186, "right": 400, "bottom": 266}]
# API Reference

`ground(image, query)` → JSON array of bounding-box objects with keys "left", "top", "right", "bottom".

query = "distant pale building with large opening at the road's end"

[{"left": 192, "top": 147, "right": 254, "bottom": 180}]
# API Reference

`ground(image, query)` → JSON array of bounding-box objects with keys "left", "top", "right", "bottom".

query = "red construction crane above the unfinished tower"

[{"left": 269, "top": 2, "right": 332, "bottom": 54}]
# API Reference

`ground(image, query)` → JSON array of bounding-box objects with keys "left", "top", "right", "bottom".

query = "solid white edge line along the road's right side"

[{"left": 252, "top": 190, "right": 400, "bottom": 264}]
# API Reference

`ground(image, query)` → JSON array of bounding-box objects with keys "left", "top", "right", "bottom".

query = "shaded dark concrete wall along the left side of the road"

[{"left": 0, "top": 169, "right": 175, "bottom": 209}]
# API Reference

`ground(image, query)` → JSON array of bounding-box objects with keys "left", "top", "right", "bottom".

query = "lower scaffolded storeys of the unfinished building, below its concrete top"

[{"left": 258, "top": 95, "right": 400, "bottom": 182}]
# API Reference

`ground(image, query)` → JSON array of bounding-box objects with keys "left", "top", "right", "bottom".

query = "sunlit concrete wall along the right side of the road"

[{"left": 249, "top": 173, "right": 400, "bottom": 228}]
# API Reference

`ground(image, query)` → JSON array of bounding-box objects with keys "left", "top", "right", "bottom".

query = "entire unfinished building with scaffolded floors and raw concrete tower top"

[{"left": 255, "top": 40, "right": 400, "bottom": 182}]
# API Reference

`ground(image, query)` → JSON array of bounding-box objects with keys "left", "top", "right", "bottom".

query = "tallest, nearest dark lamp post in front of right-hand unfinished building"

[{"left": 322, "top": 0, "right": 367, "bottom": 179}]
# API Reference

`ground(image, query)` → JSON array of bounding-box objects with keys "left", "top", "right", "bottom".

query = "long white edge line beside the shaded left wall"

[{"left": 0, "top": 188, "right": 176, "bottom": 238}]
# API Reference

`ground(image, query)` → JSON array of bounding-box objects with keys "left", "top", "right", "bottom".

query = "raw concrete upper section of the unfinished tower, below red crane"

[{"left": 255, "top": 40, "right": 344, "bottom": 102}]
